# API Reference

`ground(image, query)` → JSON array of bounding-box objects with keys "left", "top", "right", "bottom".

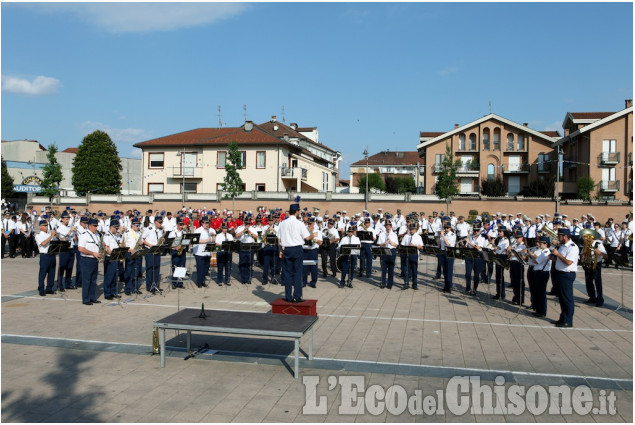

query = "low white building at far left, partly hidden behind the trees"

[{"left": 1, "top": 139, "right": 141, "bottom": 204}]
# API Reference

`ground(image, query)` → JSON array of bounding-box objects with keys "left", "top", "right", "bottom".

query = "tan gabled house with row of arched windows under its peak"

[{"left": 417, "top": 114, "right": 560, "bottom": 195}]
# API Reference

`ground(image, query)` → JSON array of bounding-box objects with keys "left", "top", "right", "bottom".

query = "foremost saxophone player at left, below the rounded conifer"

[{"left": 77, "top": 218, "right": 101, "bottom": 305}]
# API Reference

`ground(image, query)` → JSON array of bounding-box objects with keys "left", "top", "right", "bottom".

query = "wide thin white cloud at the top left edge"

[{"left": 20, "top": 2, "right": 249, "bottom": 33}]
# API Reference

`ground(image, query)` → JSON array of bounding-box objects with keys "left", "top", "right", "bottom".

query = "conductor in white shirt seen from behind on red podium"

[{"left": 278, "top": 196, "right": 313, "bottom": 303}]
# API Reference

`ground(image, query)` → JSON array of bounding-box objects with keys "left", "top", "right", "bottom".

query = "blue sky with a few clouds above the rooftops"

[{"left": 1, "top": 3, "right": 633, "bottom": 178}]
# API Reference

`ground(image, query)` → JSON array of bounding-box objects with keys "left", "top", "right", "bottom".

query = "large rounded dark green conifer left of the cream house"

[{"left": 72, "top": 130, "right": 122, "bottom": 196}]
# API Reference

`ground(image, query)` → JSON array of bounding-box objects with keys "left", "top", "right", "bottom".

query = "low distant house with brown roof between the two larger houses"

[{"left": 350, "top": 150, "right": 424, "bottom": 193}]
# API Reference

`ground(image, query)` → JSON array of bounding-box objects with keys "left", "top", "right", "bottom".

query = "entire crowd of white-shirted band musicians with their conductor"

[{"left": 2, "top": 203, "right": 633, "bottom": 327}]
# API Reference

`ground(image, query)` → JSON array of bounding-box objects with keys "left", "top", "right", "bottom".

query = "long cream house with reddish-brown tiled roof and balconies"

[{"left": 134, "top": 116, "right": 341, "bottom": 194}]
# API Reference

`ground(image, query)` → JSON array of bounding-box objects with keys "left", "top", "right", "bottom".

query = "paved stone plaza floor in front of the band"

[{"left": 1, "top": 253, "right": 633, "bottom": 422}]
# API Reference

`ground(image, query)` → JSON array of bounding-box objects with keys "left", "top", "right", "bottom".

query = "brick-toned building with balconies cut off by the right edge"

[{"left": 553, "top": 99, "right": 633, "bottom": 200}]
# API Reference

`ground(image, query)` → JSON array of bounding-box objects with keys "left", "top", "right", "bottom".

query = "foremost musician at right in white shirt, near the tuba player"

[{"left": 551, "top": 229, "right": 580, "bottom": 328}]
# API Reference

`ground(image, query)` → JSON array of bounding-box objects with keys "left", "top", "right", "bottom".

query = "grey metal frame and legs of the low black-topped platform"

[{"left": 153, "top": 310, "right": 317, "bottom": 379}]
